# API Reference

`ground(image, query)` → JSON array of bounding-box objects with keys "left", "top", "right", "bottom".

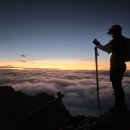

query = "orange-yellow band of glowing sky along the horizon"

[{"left": 0, "top": 60, "right": 130, "bottom": 70}]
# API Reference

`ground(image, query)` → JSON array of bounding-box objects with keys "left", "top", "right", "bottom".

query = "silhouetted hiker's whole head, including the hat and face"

[{"left": 108, "top": 25, "right": 122, "bottom": 37}]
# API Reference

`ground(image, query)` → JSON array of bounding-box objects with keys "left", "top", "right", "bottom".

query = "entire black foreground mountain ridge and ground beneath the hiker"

[{"left": 0, "top": 86, "right": 130, "bottom": 130}]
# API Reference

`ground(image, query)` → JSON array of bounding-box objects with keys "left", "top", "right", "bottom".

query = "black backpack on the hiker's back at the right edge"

[{"left": 123, "top": 38, "right": 130, "bottom": 62}]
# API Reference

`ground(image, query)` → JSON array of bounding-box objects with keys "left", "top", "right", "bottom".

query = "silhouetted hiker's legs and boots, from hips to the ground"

[{"left": 109, "top": 64, "right": 128, "bottom": 113}]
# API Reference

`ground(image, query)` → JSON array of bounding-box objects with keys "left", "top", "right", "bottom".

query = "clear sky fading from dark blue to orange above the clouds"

[{"left": 0, "top": 0, "right": 130, "bottom": 69}]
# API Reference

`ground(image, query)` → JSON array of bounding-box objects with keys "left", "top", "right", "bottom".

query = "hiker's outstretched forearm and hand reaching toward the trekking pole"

[{"left": 93, "top": 39, "right": 112, "bottom": 53}]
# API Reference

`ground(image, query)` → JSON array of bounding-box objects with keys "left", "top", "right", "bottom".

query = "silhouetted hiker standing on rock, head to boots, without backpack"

[{"left": 93, "top": 25, "right": 128, "bottom": 113}]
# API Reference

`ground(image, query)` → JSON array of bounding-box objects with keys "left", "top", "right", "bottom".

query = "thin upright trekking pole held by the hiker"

[{"left": 94, "top": 47, "right": 100, "bottom": 110}]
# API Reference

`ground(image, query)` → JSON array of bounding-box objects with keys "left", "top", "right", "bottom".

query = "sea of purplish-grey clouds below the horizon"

[{"left": 0, "top": 69, "right": 130, "bottom": 115}]
